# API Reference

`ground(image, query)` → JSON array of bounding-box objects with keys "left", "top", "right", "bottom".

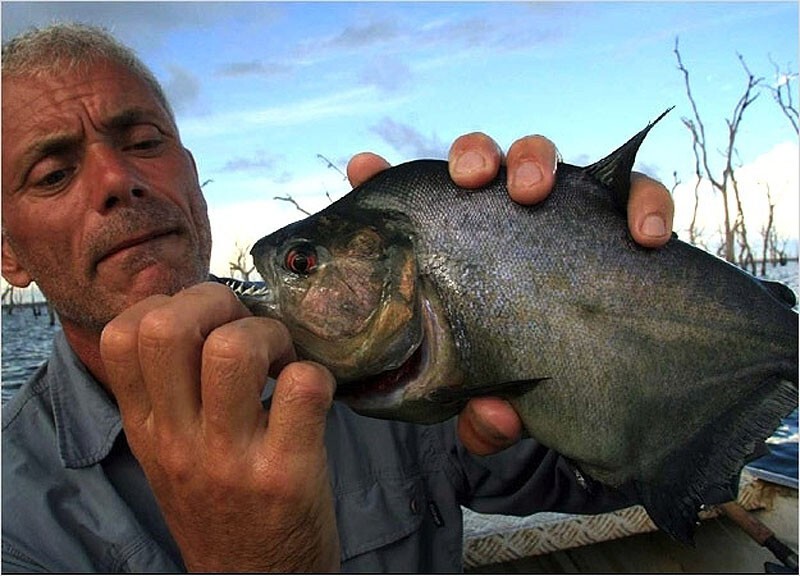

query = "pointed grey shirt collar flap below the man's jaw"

[{"left": 48, "top": 332, "right": 122, "bottom": 468}]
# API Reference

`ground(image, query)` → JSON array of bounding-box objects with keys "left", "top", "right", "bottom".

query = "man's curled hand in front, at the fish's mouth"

[{"left": 101, "top": 283, "right": 339, "bottom": 572}]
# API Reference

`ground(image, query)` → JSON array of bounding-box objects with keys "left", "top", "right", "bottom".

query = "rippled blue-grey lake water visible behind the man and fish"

[{"left": 0, "top": 262, "right": 800, "bottom": 488}]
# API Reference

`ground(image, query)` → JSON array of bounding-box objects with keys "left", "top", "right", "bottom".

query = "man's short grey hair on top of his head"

[{"left": 2, "top": 23, "right": 175, "bottom": 122}]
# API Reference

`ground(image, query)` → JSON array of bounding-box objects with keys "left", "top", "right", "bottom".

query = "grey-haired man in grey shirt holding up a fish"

[{"left": 2, "top": 25, "right": 672, "bottom": 572}]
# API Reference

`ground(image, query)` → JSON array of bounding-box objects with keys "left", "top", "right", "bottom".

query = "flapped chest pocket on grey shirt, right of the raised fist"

[{"left": 335, "top": 477, "right": 425, "bottom": 562}]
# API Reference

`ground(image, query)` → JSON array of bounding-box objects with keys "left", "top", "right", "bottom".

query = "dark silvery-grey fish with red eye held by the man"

[{"left": 216, "top": 110, "right": 798, "bottom": 542}]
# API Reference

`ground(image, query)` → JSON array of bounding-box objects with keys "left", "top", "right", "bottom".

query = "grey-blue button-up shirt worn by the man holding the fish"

[{"left": 2, "top": 333, "right": 631, "bottom": 572}]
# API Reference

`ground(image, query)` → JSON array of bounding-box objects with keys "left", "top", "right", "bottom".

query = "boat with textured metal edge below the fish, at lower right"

[{"left": 464, "top": 467, "right": 798, "bottom": 574}]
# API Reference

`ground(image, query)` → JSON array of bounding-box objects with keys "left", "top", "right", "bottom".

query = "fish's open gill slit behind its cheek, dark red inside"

[{"left": 336, "top": 282, "right": 464, "bottom": 424}]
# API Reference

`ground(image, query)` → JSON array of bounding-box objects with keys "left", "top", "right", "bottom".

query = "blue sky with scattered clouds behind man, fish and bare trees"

[{"left": 2, "top": 1, "right": 800, "bottom": 275}]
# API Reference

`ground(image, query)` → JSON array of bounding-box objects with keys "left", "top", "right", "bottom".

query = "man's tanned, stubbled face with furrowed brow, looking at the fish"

[{"left": 2, "top": 62, "right": 211, "bottom": 331}]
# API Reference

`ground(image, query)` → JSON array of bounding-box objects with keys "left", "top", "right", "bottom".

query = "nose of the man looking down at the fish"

[{"left": 86, "top": 143, "right": 146, "bottom": 212}]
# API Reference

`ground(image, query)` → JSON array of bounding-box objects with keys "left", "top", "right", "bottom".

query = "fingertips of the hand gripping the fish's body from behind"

[{"left": 347, "top": 132, "right": 674, "bottom": 454}]
